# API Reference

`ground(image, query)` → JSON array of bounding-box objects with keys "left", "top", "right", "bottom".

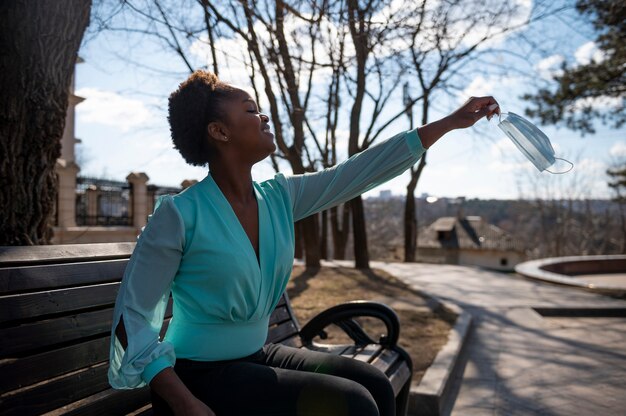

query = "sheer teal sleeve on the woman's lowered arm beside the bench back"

[{"left": 108, "top": 196, "right": 185, "bottom": 389}]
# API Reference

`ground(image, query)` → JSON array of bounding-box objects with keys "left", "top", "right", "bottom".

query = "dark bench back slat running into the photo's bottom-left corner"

[{"left": 0, "top": 363, "right": 109, "bottom": 416}]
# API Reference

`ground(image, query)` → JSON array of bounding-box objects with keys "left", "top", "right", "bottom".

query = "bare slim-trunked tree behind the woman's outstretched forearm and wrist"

[{"left": 404, "top": 1, "right": 540, "bottom": 262}]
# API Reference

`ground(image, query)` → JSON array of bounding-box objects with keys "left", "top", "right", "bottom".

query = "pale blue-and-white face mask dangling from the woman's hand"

[{"left": 498, "top": 113, "right": 574, "bottom": 173}]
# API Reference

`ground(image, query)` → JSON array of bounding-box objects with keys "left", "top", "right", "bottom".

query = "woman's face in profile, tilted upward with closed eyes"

[{"left": 213, "top": 89, "right": 276, "bottom": 164}]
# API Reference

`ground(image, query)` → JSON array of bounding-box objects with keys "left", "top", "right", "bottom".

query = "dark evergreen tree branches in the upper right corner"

[{"left": 524, "top": 0, "right": 626, "bottom": 134}]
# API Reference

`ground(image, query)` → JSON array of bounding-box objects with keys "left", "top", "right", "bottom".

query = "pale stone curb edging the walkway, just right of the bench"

[{"left": 408, "top": 300, "right": 472, "bottom": 416}]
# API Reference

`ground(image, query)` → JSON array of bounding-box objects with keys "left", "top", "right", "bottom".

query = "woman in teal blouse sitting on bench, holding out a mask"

[{"left": 109, "top": 71, "right": 498, "bottom": 416}]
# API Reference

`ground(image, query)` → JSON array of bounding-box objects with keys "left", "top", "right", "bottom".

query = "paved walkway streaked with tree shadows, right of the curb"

[{"left": 322, "top": 262, "right": 626, "bottom": 416}]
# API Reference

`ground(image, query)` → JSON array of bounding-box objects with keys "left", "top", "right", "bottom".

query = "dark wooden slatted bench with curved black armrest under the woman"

[{"left": 0, "top": 243, "right": 412, "bottom": 416}]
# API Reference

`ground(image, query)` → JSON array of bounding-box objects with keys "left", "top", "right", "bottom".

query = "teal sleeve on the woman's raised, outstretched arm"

[{"left": 277, "top": 130, "right": 425, "bottom": 221}]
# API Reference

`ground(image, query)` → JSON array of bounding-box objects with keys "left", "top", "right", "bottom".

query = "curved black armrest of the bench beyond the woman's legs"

[{"left": 300, "top": 301, "right": 400, "bottom": 347}]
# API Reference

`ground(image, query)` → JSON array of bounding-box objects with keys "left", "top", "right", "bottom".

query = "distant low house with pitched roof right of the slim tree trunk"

[{"left": 416, "top": 216, "right": 526, "bottom": 271}]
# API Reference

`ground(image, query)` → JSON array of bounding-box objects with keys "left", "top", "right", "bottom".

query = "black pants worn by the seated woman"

[{"left": 152, "top": 344, "right": 395, "bottom": 416}]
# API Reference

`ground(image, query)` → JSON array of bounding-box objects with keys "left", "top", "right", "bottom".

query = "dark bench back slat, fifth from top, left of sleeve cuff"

[{"left": 0, "top": 336, "right": 110, "bottom": 394}]
